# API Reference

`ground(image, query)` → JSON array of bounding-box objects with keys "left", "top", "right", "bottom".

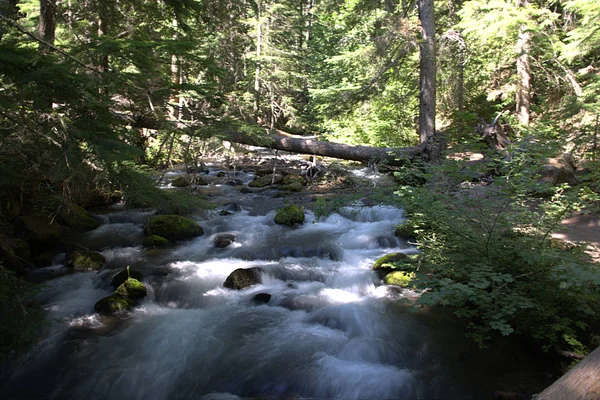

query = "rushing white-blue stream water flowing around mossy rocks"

[{"left": 0, "top": 167, "right": 556, "bottom": 400}]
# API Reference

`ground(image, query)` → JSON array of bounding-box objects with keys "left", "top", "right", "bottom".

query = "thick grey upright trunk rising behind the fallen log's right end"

[{"left": 419, "top": 0, "right": 436, "bottom": 145}]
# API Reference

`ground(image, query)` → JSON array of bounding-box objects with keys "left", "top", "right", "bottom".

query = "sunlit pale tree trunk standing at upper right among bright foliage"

[{"left": 516, "top": 0, "right": 531, "bottom": 126}]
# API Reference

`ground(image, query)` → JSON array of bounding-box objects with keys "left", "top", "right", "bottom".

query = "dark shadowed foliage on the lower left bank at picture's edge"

[{"left": 0, "top": 265, "right": 45, "bottom": 360}]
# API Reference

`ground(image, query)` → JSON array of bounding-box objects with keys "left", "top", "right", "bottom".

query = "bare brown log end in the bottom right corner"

[{"left": 537, "top": 347, "right": 600, "bottom": 400}]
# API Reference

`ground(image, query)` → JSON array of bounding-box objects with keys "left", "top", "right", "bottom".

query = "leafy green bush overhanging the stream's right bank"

[{"left": 396, "top": 153, "right": 600, "bottom": 350}]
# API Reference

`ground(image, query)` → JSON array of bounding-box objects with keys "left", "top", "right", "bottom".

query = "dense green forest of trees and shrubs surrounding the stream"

[{"left": 0, "top": 0, "right": 600, "bottom": 396}]
